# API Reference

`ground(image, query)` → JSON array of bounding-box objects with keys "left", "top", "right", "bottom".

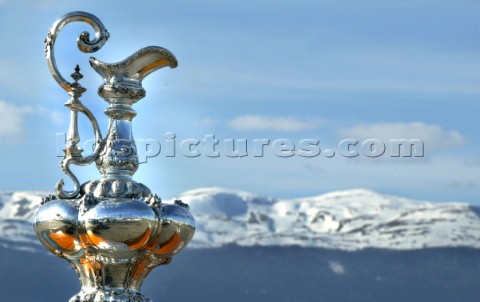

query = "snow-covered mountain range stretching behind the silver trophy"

[{"left": 0, "top": 188, "right": 480, "bottom": 250}]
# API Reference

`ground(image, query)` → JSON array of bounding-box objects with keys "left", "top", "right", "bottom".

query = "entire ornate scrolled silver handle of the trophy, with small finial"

[{"left": 45, "top": 12, "right": 110, "bottom": 199}]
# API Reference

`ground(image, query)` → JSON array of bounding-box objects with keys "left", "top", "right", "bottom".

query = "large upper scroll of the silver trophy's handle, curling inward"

[{"left": 45, "top": 11, "right": 110, "bottom": 92}]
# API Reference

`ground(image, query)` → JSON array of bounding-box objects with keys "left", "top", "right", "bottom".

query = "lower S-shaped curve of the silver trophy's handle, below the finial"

[{"left": 55, "top": 102, "right": 105, "bottom": 199}]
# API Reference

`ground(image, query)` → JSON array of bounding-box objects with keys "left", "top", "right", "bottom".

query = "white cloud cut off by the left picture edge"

[{"left": 0, "top": 101, "right": 33, "bottom": 138}]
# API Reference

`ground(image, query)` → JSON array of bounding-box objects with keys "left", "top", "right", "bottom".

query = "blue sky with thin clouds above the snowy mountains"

[{"left": 0, "top": 0, "right": 480, "bottom": 204}]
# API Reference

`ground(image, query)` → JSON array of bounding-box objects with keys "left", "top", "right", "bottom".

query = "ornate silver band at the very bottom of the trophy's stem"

[{"left": 68, "top": 289, "right": 153, "bottom": 302}]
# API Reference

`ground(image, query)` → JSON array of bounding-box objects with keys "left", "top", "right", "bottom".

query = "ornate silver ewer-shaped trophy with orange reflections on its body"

[{"left": 34, "top": 12, "right": 195, "bottom": 302}]
